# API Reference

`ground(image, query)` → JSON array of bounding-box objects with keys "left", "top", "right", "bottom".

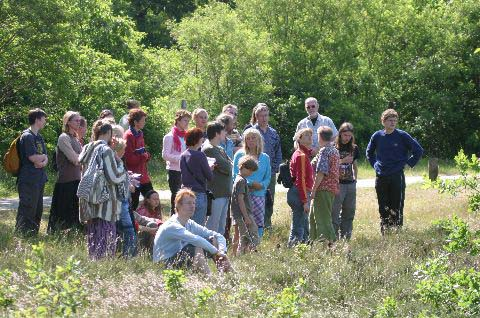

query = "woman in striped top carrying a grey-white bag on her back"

[{"left": 77, "top": 120, "right": 126, "bottom": 260}]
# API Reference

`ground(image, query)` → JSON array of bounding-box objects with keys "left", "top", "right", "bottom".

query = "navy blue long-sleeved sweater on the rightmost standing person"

[{"left": 366, "top": 129, "right": 423, "bottom": 176}]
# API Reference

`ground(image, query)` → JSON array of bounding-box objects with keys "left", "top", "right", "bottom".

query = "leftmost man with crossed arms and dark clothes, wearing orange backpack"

[{"left": 15, "top": 108, "right": 48, "bottom": 235}]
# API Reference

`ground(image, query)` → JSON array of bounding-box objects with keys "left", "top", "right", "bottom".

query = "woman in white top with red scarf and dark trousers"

[{"left": 162, "top": 109, "right": 192, "bottom": 215}]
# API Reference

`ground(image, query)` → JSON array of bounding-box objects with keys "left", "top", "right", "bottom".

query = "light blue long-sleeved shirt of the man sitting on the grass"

[{"left": 153, "top": 214, "right": 227, "bottom": 263}]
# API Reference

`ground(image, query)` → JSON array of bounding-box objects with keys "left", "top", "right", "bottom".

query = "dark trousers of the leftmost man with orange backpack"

[{"left": 15, "top": 180, "right": 45, "bottom": 235}]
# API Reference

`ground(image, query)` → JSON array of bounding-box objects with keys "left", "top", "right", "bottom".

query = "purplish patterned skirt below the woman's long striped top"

[{"left": 87, "top": 218, "right": 117, "bottom": 260}]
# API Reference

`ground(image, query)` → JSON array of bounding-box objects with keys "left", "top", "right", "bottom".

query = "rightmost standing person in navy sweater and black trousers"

[{"left": 367, "top": 109, "right": 423, "bottom": 234}]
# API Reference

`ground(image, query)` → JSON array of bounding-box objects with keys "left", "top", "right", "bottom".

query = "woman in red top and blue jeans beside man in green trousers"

[{"left": 287, "top": 128, "right": 313, "bottom": 247}]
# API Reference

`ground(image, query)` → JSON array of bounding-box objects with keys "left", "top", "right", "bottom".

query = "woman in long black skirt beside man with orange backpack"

[{"left": 47, "top": 111, "right": 82, "bottom": 233}]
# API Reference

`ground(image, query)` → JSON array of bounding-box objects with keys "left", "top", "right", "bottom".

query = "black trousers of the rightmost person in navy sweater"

[{"left": 375, "top": 171, "right": 405, "bottom": 233}]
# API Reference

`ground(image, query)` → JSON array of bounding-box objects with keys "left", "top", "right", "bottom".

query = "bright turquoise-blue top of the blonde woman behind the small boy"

[{"left": 232, "top": 149, "right": 272, "bottom": 197}]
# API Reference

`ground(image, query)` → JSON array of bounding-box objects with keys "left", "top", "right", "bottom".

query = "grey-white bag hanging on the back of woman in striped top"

[{"left": 77, "top": 145, "right": 110, "bottom": 204}]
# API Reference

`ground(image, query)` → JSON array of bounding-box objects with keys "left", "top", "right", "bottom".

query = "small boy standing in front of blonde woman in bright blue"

[{"left": 231, "top": 156, "right": 260, "bottom": 254}]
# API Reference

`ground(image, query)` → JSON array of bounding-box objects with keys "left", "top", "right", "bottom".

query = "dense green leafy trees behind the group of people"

[{"left": 0, "top": 0, "right": 480, "bottom": 157}]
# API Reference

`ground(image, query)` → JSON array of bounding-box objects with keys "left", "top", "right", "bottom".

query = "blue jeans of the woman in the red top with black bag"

[{"left": 287, "top": 186, "right": 309, "bottom": 246}]
